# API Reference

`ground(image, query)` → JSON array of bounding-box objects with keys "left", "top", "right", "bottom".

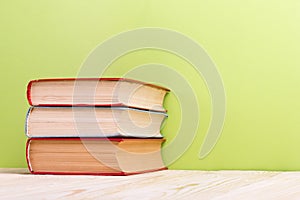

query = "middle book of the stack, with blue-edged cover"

[{"left": 25, "top": 107, "right": 167, "bottom": 138}]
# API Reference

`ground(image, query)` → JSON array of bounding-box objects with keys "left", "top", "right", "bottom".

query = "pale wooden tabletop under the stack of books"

[{"left": 0, "top": 169, "right": 300, "bottom": 200}]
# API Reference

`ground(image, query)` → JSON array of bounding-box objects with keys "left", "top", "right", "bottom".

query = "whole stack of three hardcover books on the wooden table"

[{"left": 25, "top": 78, "right": 169, "bottom": 175}]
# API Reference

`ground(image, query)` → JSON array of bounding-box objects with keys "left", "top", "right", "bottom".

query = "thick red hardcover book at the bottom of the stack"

[{"left": 26, "top": 138, "right": 167, "bottom": 175}]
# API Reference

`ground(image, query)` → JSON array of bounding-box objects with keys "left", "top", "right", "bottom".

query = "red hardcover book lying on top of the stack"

[{"left": 27, "top": 78, "right": 169, "bottom": 112}]
